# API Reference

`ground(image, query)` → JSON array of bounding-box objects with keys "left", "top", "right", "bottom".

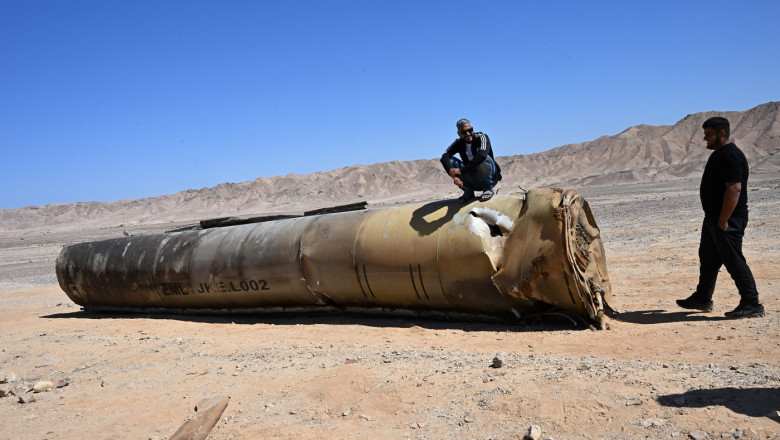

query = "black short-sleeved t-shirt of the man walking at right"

[{"left": 699, "top": 143, "right": 750, "bottom": 218}]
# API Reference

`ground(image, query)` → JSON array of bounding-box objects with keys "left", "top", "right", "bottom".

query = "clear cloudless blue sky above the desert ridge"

[{"left": 0, "top": 0, "right": 780, "bottom": 209}]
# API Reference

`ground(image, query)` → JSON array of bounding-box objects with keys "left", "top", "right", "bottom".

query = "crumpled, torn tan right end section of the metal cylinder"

[{"left": 493, "top": 189, "right": 612, "bottom": 327}]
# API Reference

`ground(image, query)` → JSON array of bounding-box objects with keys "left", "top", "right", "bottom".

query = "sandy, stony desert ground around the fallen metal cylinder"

[{"left": 0, "top": 174, "right": 780, "bottom": 439}]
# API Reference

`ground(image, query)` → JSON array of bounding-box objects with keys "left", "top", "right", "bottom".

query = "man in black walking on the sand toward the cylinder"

[{"left": 677, "top": 117, "right": 764, "bottom": 318}]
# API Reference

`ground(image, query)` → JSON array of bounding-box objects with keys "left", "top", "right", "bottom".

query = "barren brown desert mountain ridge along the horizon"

[{"left": 0, "top": 102, "right": 780, "bottom": 230}]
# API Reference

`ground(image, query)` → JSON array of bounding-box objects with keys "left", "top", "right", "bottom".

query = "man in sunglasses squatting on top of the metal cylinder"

[{"left": 441, "top": 119, "right": 501, "bottom": 203}]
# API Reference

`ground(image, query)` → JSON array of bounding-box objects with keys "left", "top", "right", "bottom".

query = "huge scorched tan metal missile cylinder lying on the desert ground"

[{"left": 56, "top": 189, "right": 611, "bottom": 327}]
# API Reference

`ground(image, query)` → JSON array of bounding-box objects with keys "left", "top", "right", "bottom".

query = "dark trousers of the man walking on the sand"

[{"left": 696, "top": 217, "right": 758, "bottom": 305}]
